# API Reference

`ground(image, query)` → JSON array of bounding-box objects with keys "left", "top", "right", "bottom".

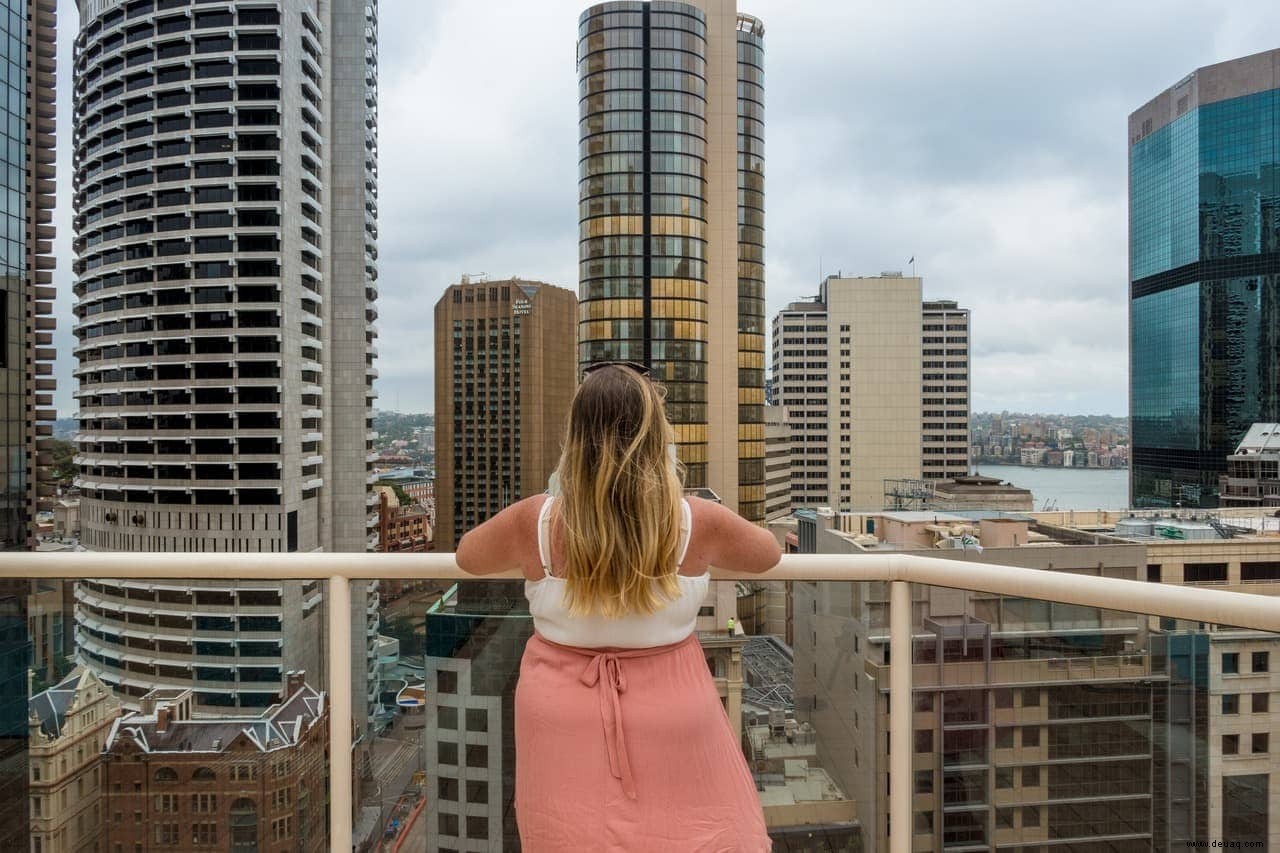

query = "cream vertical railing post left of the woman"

[{"left": 325, "top": 575, "right": 352, "bottom": 853}]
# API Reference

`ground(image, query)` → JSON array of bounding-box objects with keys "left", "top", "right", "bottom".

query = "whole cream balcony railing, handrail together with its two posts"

[{"left": 0, "top": 552, "right": 1280, "bottom": 853}]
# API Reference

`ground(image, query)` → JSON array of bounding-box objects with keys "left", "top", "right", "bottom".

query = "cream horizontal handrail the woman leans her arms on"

[{"left": 12, "top": 551, "right": 1280, "bottom": 633}]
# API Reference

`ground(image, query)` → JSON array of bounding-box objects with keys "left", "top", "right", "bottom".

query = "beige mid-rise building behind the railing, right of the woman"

[{"left": 792, "top": 512, "right": 1162, "bottom": 853}]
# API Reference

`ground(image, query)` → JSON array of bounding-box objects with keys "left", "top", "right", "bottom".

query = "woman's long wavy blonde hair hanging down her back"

[{"left": 553, "top": 365, "right": 682, "bottom": 619}]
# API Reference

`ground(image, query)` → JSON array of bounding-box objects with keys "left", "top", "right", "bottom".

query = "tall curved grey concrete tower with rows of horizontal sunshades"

[{"left": 74, "top": 0, "right": 378, "bottom": 721}]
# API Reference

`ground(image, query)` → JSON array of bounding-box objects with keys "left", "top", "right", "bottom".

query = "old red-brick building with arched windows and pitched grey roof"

[{"left": 101, "top": 672, "right": 329, "bottom": 853}]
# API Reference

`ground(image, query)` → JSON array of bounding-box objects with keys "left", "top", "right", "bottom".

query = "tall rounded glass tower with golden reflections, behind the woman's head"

[{"left": 577, "top": 0, "right": 765, "bottom": 521}]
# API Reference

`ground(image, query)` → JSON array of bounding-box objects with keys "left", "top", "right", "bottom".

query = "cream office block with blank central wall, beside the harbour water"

[{"left": 773, "top": 273, "right": 969, "bottom": 510}]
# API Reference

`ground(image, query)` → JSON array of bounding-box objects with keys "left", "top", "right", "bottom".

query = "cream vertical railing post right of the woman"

[{"left": 888, "top": 580, "right": 914, "bottom": 853}]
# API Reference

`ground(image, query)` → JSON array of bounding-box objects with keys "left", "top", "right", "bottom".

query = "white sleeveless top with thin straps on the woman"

[{"left": 525, "top": 497, "right": 712, "bottom": 648}]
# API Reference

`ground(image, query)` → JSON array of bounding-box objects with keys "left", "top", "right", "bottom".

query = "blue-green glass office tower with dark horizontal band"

[{"left": 1129, "top": 50, "right": 1280, "bottom": 507}]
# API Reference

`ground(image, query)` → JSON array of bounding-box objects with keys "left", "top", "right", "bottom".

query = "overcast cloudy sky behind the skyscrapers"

[{"left": 49, "top": 0, "right": 1280, "bottom": 415}]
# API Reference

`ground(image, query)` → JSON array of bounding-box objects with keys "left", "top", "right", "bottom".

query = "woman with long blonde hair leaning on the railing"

[{"left": 457, "top": 364, "right": 781, "bottom": 853}]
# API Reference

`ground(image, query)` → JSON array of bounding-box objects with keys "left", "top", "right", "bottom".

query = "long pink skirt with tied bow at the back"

[{"left": 516, "top": 634, "right": 772, "bottom": 853}]
